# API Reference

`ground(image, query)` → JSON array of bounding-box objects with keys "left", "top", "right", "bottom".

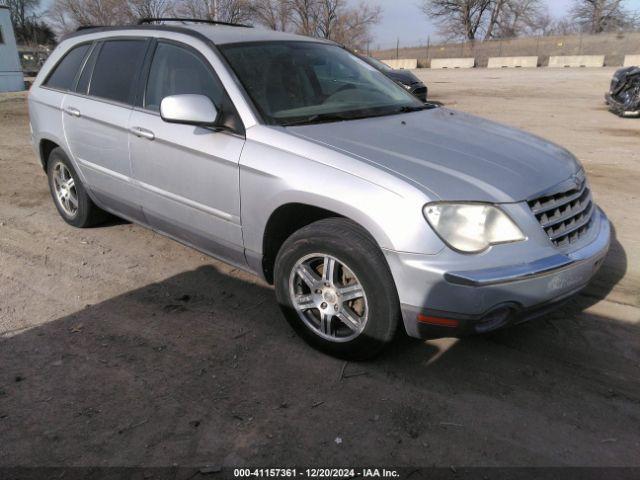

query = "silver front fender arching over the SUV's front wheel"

[{"left": 240, "top": 129, "right": 444, "bottom": 255}]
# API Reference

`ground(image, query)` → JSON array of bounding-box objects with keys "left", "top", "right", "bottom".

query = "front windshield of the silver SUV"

[{"left": 219, "top": 42, "right": 426, "bottom": 126}]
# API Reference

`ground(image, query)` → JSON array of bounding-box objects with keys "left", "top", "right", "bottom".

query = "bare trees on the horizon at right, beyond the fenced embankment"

[{"left": 421, "top": 0, "right": 640, "bottom": 41}]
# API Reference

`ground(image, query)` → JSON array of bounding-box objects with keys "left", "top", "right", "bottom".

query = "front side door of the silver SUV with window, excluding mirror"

[{"left": 129, "top": 40, "right": 245, "bottom": 264}]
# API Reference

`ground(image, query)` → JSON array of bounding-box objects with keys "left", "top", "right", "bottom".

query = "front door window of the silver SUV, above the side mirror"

[{"left": 145, "top": 43, "right": 223, "bottom": 112}]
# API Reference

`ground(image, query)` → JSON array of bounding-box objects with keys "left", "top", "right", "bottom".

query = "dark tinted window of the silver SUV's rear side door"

[{"left": 89, "top": 40, "right": 146, "bottom": 103}]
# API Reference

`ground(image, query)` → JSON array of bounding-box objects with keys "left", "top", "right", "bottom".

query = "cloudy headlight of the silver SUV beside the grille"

[{"left": 424, "top": 203, "right": 525, "bottom": 253}]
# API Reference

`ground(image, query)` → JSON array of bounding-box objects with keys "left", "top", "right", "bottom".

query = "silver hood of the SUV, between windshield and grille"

[{"left": 287, "top": 108, "right": 581, "bottom": 202}]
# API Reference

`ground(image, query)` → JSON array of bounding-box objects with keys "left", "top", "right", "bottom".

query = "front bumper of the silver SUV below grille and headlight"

[{"left": 387, "top": 209, "right": 611, "bottom": 338}]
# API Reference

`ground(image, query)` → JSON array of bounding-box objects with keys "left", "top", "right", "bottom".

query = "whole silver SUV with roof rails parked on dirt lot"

[{"left": 29, "top": 23, "right": 610, "bottom": 358}]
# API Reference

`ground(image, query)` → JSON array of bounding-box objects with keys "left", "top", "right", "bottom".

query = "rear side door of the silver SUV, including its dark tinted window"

[{"left": 62, "top": 38, "right": 150, "bottom": 221}]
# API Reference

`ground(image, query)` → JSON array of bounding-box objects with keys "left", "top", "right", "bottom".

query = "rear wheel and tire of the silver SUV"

[{"left": 47, "top": 147, "right": 109, "bottom": 228}]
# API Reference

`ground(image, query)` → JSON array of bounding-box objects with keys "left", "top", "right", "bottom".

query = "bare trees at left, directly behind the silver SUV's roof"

[{"left": 0, "top": 0, "right": 382, "bottom": 48}]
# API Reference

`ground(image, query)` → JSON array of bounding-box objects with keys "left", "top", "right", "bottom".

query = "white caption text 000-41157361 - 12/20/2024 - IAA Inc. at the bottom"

[{"left": 233, "top": 468, "right": 400, "bottom": 478}]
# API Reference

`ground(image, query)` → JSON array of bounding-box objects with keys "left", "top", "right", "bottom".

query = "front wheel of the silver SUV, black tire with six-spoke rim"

[{"left": 275, "top": 218, "right": 400, "bottom": 360}]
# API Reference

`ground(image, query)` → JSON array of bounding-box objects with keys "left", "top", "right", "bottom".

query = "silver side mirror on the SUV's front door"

[{"left": 160, "top": 94, "right": 220, "bottom": 127}]
